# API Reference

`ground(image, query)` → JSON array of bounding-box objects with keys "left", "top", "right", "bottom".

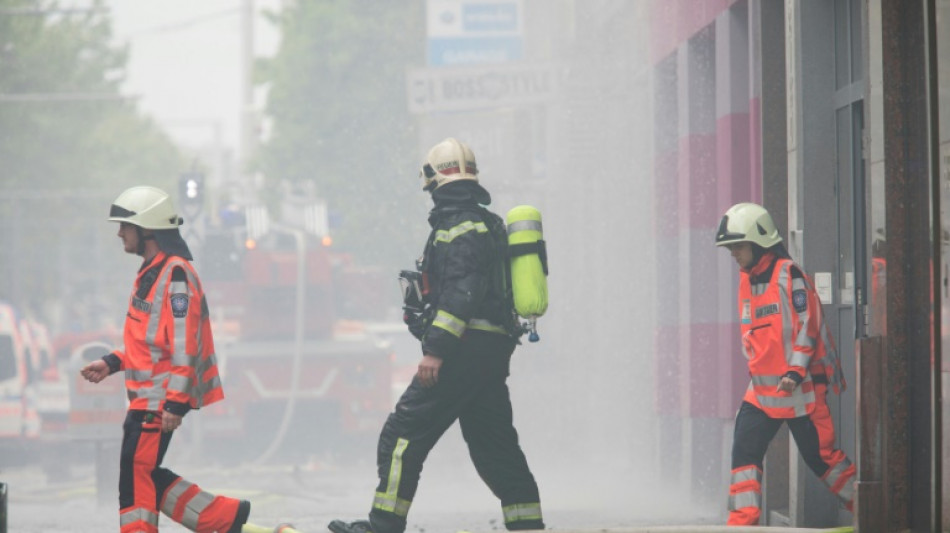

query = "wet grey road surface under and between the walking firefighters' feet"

[{"left": 0, "top": 435, "right": 722, "bottom": 533}]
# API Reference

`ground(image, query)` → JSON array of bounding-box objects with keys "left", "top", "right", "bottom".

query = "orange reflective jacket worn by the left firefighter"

[{"left": 107, "top": 252, "right": 224, "bottom": 414}]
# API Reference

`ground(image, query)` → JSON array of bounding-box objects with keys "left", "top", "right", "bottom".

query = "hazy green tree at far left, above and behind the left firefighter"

[{"left": 0, "top": 0, "right": 184, "bottom": 313}]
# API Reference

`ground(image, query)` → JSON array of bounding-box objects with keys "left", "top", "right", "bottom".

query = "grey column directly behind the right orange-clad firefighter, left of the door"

[{"left": 785, "top": 2, "right": 850, "bottom": 527}]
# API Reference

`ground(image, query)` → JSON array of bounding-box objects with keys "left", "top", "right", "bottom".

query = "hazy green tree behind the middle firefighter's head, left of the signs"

[{"left": 258, "top": 0, "right": 426, "bottom": 268}]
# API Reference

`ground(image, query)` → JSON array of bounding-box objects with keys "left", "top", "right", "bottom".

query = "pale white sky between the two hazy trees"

[{"left": 106, "top": 0, "right": 281, "bottom": 148}]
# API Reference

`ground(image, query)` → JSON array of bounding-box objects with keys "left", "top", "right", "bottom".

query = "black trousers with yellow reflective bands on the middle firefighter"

[{"left": 370, "top": 329, "right": 543, "bottom": 533}]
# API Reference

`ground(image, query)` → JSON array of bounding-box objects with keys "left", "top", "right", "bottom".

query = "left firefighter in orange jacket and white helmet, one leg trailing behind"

[{"left": 80, "top": 186, "right": 294, "bottom": 533}]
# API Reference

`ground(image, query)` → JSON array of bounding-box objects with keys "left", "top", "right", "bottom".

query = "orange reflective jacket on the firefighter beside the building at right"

[{"left": 739, "top": 253, "right": 845, "bottom": 418}]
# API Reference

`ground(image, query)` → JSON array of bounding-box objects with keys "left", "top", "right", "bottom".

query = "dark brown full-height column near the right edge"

[{"left": 872, "top": 0, "right": 941, "bottom": 531}]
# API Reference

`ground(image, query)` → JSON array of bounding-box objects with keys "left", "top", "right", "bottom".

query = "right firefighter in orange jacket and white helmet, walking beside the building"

[{"left": 716, "top": 203, "right": 855, "bottom": 525}]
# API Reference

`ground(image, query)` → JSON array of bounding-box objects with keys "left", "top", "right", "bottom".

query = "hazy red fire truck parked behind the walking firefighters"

[{"left": 198, "top": 236, "right": 395, "bottom": 460}]
